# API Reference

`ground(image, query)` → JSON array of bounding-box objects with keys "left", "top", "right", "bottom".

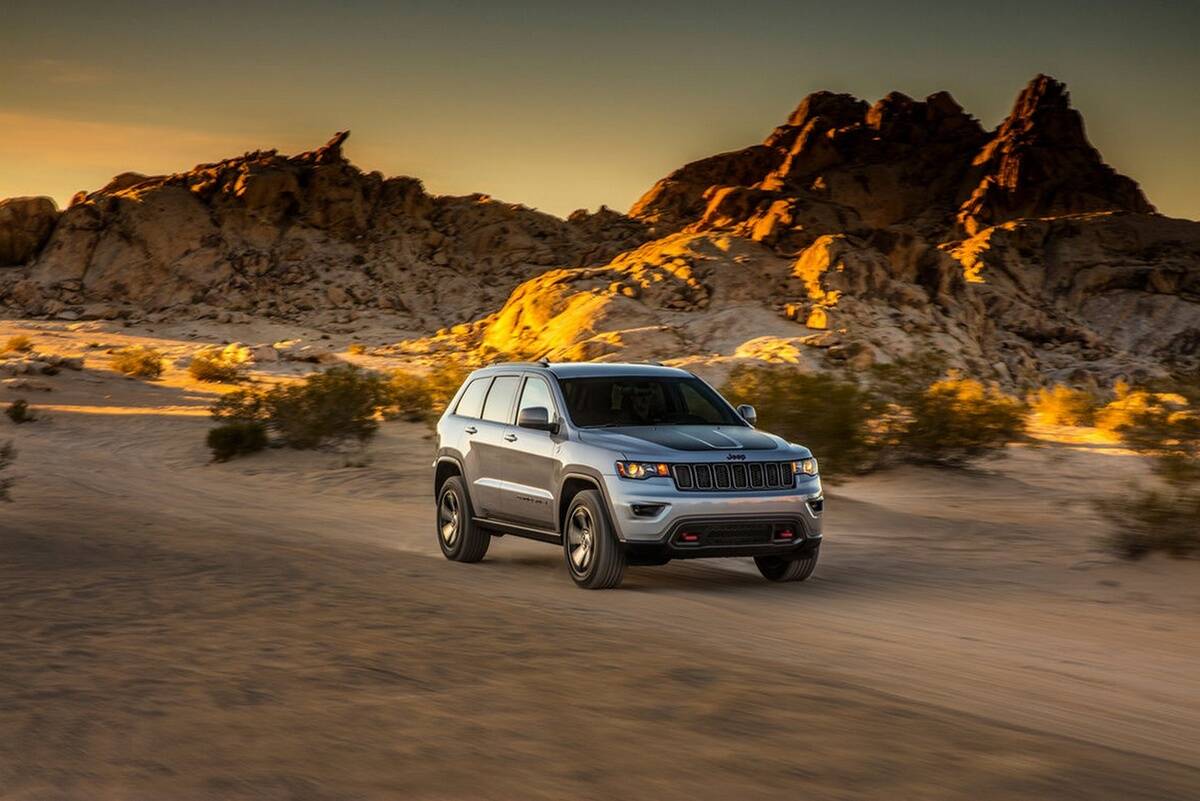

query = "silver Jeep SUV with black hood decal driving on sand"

[{"left": 433, "top": 362, "right": 823, "bottom": 589}]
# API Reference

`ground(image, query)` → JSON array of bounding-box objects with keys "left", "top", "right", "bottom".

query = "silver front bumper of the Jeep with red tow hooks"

[{"left": 604, "top": 475, "right": 823, "bottom": 559}]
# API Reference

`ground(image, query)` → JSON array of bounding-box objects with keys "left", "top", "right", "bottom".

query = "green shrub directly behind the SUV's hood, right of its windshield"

[{"left": 721, "top": 367, "right": 882, "bottom": 481}]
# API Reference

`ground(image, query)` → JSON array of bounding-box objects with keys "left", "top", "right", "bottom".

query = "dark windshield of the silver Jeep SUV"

[{"left": 559, "top": 375, "right": 746, "bottom": 428}]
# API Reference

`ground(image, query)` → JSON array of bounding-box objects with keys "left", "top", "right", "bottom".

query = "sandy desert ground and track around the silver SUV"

[{"left": 0, "top": 320, "right": 1200, "bottom": 801}]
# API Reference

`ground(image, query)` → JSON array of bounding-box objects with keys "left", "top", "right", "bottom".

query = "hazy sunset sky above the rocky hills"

[{"left": 0, "top": 0, "right": 1200, "bottom": 219}]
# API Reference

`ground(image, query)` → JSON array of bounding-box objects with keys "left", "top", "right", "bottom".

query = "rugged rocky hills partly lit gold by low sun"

[{"left": 0, "top": 76, "right": 1200, "bottom": 384}]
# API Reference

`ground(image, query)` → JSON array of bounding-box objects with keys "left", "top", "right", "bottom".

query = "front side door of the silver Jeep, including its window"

[{"left": 503, "top": 375, "right": 562, "bottom": 531}]
